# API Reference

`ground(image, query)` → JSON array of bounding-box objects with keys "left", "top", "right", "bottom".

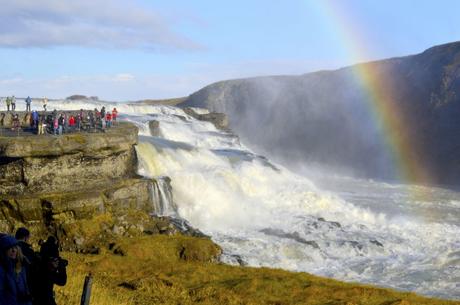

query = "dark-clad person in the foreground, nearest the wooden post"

[{"left": 33, "top": 236, "right": 67, "bottom": 305}]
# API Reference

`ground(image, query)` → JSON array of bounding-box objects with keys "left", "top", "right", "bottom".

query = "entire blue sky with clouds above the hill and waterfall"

[{"left": 0, "top": 0, "right": 460, "bottom": 101}]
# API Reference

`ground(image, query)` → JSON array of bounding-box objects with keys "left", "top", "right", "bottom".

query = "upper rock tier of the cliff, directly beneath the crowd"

[{"left": 0, "top": 123, "right": 137, "bottom": 195}]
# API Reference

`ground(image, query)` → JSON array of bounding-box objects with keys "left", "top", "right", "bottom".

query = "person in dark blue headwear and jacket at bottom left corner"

[{"left": 0, "top": 235, "right": 32, "bottom": 305}]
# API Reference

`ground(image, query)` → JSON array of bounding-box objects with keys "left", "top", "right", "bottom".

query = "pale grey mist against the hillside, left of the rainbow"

[{"left": 183, "top": 70, "right": 396, "bottom": 180}]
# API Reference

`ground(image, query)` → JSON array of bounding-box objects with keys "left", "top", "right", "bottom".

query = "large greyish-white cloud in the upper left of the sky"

[{"left": 0, "top": 0, "right": 201, "bottom": 50}]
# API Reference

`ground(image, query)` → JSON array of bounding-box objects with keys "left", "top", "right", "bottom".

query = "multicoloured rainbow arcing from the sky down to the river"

[{"left": 306, "top": 0, "right": 432, "bottom": 188}]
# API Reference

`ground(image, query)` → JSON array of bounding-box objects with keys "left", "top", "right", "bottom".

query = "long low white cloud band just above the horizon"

[{"left": 0, "top": 59, "right": 341, "bottom": 101}]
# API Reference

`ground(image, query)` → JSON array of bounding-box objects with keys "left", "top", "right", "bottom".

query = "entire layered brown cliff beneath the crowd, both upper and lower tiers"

[{"left": 0, "top": 123, "right": 164, "bottom": 248}]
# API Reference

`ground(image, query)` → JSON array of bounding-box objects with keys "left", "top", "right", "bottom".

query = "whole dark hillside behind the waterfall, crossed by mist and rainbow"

[{"left": 181, "top": 42, "right": 460, "bottom": 186}]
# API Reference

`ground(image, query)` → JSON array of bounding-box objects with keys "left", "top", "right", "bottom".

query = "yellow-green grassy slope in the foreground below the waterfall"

[{"left": 57, "top": 235, "right": 460, "bottom": 305}]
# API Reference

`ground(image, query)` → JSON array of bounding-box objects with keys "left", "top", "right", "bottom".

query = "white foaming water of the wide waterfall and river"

[{"left": 4, "top": 101, "right": 460, "bottom": 299}]
